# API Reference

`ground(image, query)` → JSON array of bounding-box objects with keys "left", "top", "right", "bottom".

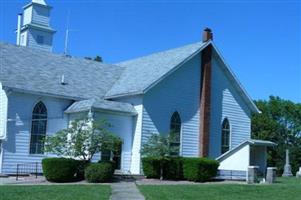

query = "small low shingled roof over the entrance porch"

[{"left": 65, "top": 99, "right": 137, "bottom": 115}]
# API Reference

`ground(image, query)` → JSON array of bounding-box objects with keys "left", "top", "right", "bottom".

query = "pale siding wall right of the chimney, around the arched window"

[{"left": 209, "top": 52, "right": 251, "bottom": 158}]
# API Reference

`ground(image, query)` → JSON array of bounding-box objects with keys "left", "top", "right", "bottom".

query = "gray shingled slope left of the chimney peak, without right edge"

[{"left": 106, "top": 42, "right": 207, "bottom": 98}]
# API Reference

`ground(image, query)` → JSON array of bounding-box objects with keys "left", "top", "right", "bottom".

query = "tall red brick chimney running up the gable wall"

[{"left": 199, "top": 28, "right": 213, "bottom": 157}]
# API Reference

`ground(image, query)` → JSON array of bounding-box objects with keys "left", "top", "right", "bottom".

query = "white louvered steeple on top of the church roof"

[{"left": 17, "top": 0, "right": 55, "bottom": 51}]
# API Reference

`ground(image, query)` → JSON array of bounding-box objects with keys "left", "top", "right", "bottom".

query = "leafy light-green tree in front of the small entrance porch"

[{"left": 45, "top": 118, "right": 121, "bottom": 161}]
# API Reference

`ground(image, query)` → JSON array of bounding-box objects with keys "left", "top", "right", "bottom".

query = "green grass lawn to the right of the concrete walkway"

[{"left": 139, "top": 177, "right": 301, "bottom": 200}]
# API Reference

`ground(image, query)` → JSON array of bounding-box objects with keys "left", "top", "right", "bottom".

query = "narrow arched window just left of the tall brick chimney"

[{"left": 170, "top": 112, "right": 181, "bottom": 156}]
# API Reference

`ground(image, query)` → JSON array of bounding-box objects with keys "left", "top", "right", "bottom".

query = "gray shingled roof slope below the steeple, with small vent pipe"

[{"left": 0, "top": 42, "right": 123, "bottom": 99}]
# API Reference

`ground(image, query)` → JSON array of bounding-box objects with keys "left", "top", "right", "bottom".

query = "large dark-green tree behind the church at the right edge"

[{"left": 252, "top": 96, "right": 301, "bottom": 173}]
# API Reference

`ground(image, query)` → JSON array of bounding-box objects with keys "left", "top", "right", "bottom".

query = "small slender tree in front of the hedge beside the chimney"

[{"left": 140, "top": 134, "right": 178, "bottom": 180}]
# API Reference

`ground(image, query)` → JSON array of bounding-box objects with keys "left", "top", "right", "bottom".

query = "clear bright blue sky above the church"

[{"left": 0, "top": 0, "right": 301, "bottom": 102}]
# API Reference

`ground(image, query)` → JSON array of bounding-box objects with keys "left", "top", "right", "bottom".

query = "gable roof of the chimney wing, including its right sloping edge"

[{"left": 105, "top": 41, "right": 260, "bottom": 113}]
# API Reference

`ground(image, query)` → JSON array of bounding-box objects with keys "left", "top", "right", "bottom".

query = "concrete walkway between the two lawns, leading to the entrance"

[{"left": 110, "top": 182, "right": 145, "bottom": 200}]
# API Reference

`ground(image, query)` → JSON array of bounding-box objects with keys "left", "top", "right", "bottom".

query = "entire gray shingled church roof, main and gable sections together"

[{"left": 0, "top": 39, "right": 259, "bottom": 112}]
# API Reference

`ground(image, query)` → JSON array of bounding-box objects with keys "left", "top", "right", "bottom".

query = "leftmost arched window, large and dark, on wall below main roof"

[{"left": 30, "top": 101, "right": 47, "bottom": 154}]
